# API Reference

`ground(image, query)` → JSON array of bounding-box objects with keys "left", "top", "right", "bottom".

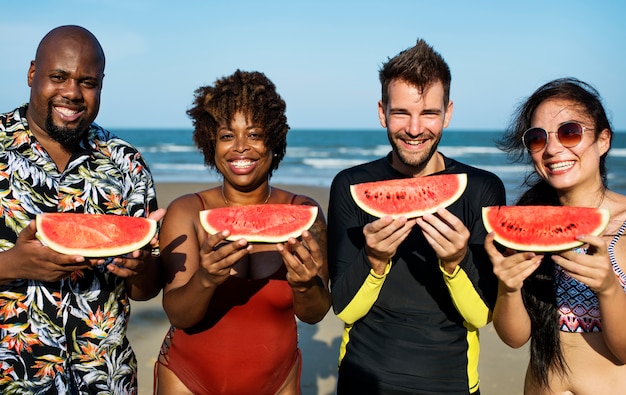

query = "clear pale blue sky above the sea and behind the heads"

[{"left": 0, "top": 0, "right": 626, "bottom": 130}]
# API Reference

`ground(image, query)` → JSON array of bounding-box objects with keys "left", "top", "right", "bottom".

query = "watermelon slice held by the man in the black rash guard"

[{"left": 350, "top": 173, "right": 467, "bottom": 218}]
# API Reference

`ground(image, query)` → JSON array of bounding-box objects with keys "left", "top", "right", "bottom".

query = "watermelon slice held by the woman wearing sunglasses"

[{"left": 483, "top": 206, "right": 610, "bottom": 252}]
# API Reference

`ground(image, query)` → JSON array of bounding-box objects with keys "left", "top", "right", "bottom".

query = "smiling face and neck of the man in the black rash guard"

[{"left": 378, "top": 80, "right": 453, "bottom": 176}]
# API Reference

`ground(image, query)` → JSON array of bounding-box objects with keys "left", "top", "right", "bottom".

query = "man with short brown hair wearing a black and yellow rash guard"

[{"left": 328, "top": 40, "right": 505, "bottom": 395}]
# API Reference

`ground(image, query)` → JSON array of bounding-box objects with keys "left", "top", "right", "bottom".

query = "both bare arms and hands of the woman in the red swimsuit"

[{"left": 161, "top": 196, "right": 331, "bottom": 328}]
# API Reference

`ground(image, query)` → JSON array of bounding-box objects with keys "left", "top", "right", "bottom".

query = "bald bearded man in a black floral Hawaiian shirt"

[{"left": 0, "top": 26, "right": 164, "bottom": 394}]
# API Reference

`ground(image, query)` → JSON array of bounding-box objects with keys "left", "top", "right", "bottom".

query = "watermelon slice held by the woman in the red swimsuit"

[{"left": 200, "top": 204, "right": 317, "bottom": 243}]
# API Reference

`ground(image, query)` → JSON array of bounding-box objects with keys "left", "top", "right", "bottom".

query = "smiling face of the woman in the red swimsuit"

[{"left": 215, "top": 112, "right": 272, "bottom": 190}]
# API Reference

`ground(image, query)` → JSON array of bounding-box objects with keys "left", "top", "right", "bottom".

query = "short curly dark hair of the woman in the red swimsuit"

[{"left": 187, "top": 70, "right": 289, "bottom": 176}]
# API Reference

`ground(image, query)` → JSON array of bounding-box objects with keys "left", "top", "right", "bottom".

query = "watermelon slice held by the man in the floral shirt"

[{"left": 36, "top": 213, "right": 157, "bottom": 257}]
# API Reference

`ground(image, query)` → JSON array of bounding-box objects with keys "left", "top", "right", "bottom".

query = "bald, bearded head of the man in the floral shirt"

[{"left": 27, "top": 27, "right": 104, "bottom": 150}]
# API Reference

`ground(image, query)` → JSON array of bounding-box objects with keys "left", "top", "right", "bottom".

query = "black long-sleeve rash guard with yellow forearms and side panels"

[{"left": 328, "top": 153, "right": 506, "bottom": 394}]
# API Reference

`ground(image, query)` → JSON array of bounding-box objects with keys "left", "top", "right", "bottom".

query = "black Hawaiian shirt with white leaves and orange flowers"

[{"left": 0, "top": 105, "right": 157, "bottom": 394}]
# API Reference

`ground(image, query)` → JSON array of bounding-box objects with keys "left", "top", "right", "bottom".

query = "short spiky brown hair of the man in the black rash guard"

[{"left": 378, "top": 39, "right": 452, "bottom": 106}]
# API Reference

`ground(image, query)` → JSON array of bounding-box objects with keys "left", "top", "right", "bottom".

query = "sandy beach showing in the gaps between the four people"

[{"left": 128, "top": 183, "right": 528, "bottom": 395}]
